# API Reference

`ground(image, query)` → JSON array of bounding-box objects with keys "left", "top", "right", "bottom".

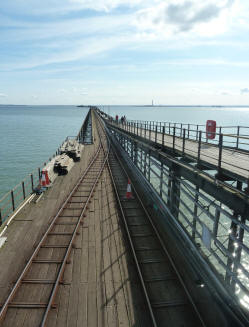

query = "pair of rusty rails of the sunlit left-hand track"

[{"left": 0, "top": 115, "right": 108, "bottom": 326}]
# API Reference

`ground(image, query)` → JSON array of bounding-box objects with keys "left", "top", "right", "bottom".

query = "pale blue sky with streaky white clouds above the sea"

[{"left": 0, "top": 0, "right": 249, "bottom": 105}]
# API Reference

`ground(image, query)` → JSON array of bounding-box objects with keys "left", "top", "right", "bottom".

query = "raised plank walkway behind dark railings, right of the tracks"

[{"left": 107, "top": 120, "right": 249, "bottom": 183}]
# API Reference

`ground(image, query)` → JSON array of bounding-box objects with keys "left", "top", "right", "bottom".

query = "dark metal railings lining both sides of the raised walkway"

[{"left": 100, "top": 117, "right": 249, "bottom": 182}]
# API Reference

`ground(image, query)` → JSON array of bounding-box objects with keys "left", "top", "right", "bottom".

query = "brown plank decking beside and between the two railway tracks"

[{"left": 0, "top": 114, "right": 150, "bottom": 327}]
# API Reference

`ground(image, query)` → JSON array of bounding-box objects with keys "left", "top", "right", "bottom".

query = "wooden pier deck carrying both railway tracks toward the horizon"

[{"left": 0, "top": 111, "right": 248, "bottom": 327}]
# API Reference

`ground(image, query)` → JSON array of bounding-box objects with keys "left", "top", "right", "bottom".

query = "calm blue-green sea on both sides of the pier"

[{"left": 0, "top": 105, "right": 249, "bottom": 198}]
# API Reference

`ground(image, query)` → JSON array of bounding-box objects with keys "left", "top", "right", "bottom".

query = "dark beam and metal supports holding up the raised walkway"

[{"left": 107, "top": 118, "right": 249, "bottom": 310}]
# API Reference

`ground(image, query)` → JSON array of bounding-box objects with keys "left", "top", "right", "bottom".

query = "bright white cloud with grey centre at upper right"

[{"left": 135, "top": 0, "right": 236, "bottom": 37}]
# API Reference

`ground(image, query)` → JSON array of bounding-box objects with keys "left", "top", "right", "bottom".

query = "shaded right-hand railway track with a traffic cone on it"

[{"left": 109, "top": 146, "right": 205, "bottom": 327}]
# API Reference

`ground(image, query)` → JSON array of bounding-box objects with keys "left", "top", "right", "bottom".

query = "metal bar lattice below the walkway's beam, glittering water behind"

[{"left": 110, "top": 125, "right": 249, "bottom": 309}]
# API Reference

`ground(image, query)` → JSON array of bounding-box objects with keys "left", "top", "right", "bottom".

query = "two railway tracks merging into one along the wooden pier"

[{"left": 0, "top": 111, "right": 205, "bottom": 327}]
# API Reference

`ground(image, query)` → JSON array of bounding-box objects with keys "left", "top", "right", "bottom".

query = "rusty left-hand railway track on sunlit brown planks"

[{"left": 0, "top": 112, "right": 108, "bottom": 327}]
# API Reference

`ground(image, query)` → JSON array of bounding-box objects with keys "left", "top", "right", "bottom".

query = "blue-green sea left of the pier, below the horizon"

[{"left": 0, "top": 106, "right": 88, "bottom": 199}]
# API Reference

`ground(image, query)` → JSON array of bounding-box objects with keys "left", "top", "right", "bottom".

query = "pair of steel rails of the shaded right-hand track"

[{"left": 104, "top": 138, "right": 206, "bottom": 327}]
